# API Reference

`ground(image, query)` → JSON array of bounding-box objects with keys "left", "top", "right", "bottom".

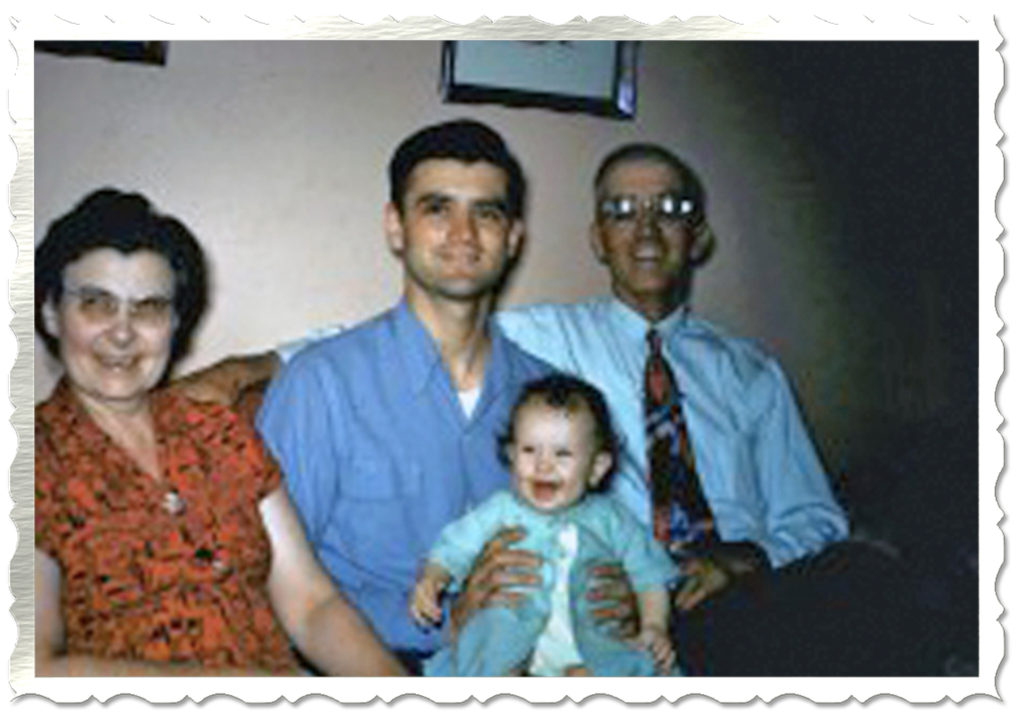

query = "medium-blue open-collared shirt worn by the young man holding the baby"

[{"left": 258, "top": 301, "right": 553, "bottom": 652}]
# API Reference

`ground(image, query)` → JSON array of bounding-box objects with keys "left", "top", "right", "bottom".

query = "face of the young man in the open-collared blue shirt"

[{"left": 385, "top": 159, "right": 522, "bottom": 300}]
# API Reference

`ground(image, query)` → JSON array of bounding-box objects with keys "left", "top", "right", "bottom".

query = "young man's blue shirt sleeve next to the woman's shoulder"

[{"left": 256, "top": 352, "right": 345, "bottom": 545}]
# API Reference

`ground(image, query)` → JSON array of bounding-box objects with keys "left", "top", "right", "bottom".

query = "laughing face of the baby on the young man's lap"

[{"left": 508, "top": 400, "right": 611, "bottom": 513}]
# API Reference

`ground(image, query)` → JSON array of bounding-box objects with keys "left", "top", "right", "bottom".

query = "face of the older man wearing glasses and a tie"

[{"left": 591, "top": 160, "right": 693, "bottom": 320}]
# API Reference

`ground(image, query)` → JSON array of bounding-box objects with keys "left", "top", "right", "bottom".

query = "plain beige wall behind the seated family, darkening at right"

[{"left": 35, "top": 42, "right": 976, "bottom": 481}]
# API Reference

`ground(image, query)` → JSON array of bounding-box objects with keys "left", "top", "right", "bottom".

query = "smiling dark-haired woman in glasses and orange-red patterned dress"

[{"left": 35, "top": 189, "right": 402, "bottom": 675}]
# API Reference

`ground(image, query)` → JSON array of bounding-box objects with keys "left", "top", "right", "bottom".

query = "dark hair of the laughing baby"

[{"left": 498, "top": 374, "right": 618, "bottom": 491}]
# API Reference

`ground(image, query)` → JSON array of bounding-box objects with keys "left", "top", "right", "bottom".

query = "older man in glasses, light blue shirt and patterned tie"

[{"left": 501, "top": 143, "right": 848, "bottom": 673}]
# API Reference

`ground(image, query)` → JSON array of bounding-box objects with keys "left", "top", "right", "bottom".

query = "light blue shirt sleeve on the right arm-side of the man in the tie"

[{"left": 752, "top": 360, "right": 849, "bottom": 567}]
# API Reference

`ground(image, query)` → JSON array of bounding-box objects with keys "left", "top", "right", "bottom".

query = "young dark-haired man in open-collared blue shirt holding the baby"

[{"left": 258, "top": 121, "right": 551, "bottom": 671}]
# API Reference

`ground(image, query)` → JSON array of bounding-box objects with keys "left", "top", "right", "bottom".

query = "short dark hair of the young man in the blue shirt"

[{"left": 388, "top": 120, "right": 526, "bottom": 219}]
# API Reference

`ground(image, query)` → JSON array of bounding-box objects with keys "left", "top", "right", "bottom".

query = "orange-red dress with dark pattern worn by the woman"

[{"left": 36, "top": 382, "right": 297, "bottom": 673}]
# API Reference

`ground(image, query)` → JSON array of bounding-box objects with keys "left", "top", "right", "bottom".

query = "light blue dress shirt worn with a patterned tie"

[{"left": 498, "top": 298, "right": 849, "bottom": 567}]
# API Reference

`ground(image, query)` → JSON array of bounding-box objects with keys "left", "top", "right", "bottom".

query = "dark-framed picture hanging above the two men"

[{"left": 441, "top": 40, "right": 640, "bottom": 120}]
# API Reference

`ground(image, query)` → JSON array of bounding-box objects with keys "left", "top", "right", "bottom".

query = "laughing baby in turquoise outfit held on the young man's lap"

[{"left": 410, "top": 375, "right": 677, "bottom": 676}]
